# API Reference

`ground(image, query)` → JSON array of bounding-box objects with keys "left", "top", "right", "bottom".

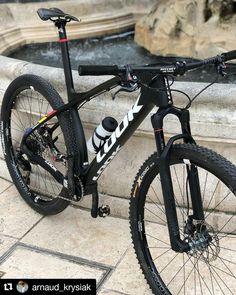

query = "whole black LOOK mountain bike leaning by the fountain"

[{"left": 1, "top": 8, "right": 236, "bottom": 295}]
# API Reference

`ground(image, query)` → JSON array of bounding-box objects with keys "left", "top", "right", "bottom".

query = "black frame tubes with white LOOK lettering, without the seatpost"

[{"left": 21, "top": 78, "right": 154, "bottom": 194}]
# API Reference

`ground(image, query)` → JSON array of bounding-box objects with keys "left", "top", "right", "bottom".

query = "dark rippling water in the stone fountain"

[{"left": 9, "top": 32, "right": 236, "bottom": 83}]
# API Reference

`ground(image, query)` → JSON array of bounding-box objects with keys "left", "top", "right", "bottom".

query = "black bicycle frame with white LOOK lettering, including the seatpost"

[{"left": 21, "top": 19, "right": 172, "bottom": 195}]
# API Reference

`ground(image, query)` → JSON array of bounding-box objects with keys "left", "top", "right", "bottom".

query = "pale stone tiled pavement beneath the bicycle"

[{"left": 0, "top": 179, "right": 152, "bottom": 295}]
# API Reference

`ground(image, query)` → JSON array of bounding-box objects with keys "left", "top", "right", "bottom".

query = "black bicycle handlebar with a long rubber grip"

[{"left": 78, "top": 50, "right": 236, "bottom": 76}]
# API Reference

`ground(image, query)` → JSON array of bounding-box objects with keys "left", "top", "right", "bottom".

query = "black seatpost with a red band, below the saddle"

[{"left": 55, "top": 19, "right": 75, "bottom": 101}]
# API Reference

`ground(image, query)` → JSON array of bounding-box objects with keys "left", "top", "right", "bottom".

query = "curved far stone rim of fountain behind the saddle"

[{"left": 0, "top": 0, "right": 154, "bottom": 55}]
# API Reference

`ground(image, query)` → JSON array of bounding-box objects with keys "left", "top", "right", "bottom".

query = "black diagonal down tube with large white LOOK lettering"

[{"left": 85, "top": 96, "right": 154, "bottom": 184}]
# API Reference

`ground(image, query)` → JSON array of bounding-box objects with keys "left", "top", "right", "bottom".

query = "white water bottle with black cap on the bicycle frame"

[{"left": 87, "top": 117, "right": 118, "bottom": 154}]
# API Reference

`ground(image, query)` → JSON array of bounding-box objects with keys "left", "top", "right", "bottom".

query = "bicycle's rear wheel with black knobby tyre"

[{"left": 1, "top": 75, "right": 70, "bottom": 215}]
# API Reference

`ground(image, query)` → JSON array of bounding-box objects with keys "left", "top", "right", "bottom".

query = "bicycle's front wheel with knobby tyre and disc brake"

[{"left": 130, "top": 144, "right": 236, "bottom": 295}]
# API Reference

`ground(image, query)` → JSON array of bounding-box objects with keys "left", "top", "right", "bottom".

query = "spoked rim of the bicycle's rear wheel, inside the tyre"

[{"left": 7, "top": 87, "right": 66, "bottom": 205}]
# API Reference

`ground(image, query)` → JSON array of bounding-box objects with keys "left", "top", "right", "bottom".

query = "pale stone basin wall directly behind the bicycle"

[{"left": 0, "top": 57, "right": 236, "bottom": 216}]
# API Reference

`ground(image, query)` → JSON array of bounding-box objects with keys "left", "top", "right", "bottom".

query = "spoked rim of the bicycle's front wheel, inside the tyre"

[{"left": 138, "top": 162, "right": 236, "bottom": 295}]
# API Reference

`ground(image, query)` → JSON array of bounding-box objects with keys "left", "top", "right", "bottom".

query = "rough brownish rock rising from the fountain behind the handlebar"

[{"left": 135, "top": 0, "right": 236, "bottom": 58}]
